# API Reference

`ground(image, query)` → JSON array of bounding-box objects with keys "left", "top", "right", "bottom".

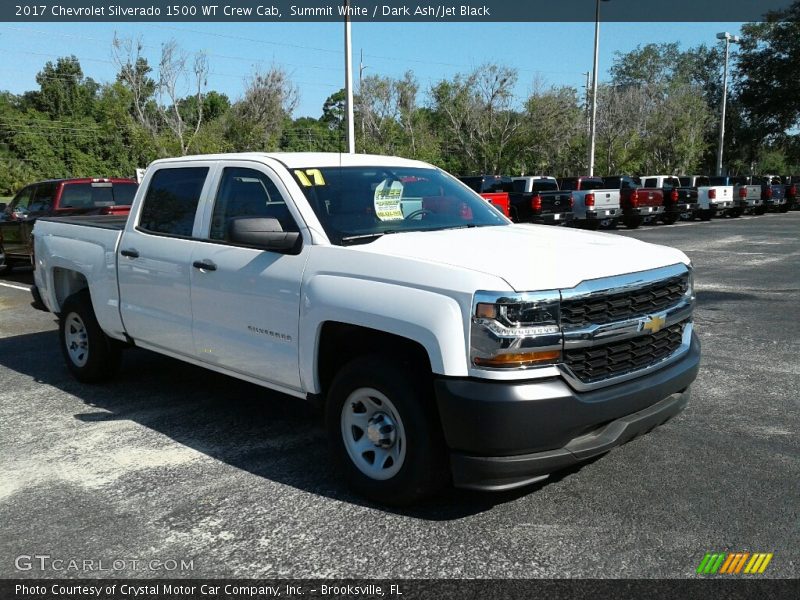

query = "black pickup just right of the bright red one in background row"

[{"left": 507, "top": 176, "right": 572, "bottom": 225}]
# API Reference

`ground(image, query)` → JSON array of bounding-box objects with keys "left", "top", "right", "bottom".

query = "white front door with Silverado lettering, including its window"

[{"left": 190, "top": 161, "right": 308, "bottom": 390}]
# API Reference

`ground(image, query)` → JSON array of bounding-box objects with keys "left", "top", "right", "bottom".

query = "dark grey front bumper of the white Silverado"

[{"left": 435, "top": 333, "right": 700, "bottom": 490}]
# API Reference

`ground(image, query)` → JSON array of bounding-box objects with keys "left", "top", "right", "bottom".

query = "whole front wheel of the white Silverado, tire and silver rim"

[{"left": 325, "top": 356, "right": 449, "bottom": 506}]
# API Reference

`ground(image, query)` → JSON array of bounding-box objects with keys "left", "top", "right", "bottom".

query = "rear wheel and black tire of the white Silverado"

[{"left": 58, "top": 289, "right": 121, "bottom": 383}]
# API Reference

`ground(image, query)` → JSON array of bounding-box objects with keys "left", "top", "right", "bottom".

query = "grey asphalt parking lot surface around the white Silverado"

[{"left": 0, "top": 212, "right": 800, "bottom": 578}]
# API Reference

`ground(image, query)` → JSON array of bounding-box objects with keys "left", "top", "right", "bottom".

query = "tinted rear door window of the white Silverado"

[{"left": 139, "top": 167, "right": 208, "bottom": 237}]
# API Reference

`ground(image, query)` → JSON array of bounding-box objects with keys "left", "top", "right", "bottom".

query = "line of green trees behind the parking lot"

[{"left": 0, "top": 12, "right": 800, "bottom": 196}]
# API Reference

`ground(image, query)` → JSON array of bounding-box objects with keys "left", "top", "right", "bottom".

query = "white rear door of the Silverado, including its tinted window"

[{"left": 117, "top": 161, "right": 215, "bottom": 357}]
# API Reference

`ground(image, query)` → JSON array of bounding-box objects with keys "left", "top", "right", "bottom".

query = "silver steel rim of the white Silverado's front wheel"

[{"left": 340, "top": 387, "right": 407, "bottom": 481}]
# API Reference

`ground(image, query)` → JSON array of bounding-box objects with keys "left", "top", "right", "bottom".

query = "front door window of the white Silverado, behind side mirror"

[{"left": 209, "top": 167, "right": 300, "bottom": 240}]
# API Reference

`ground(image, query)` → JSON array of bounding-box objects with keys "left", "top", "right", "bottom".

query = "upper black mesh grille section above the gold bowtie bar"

[{"left": 561, "top": 273, "right": 689, "bottom": 329}]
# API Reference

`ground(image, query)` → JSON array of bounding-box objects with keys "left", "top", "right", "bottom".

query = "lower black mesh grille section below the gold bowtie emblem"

[{"left": 564, "top": 320, "right": 689, "bottom": 384}]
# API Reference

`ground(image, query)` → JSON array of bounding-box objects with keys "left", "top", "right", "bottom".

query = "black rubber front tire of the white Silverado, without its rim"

[{"left": 325, "top": 355, "right": 450, "bottom": 506}]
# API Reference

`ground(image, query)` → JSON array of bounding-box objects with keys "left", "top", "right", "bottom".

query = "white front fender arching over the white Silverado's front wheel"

[{"left": 299, "top": 275, "right": 468, "bottom": 393}]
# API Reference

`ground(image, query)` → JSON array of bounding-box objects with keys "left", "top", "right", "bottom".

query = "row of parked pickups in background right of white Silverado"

[{"left": 460, "top": 175, "right": 800, "bottom": 229}]
